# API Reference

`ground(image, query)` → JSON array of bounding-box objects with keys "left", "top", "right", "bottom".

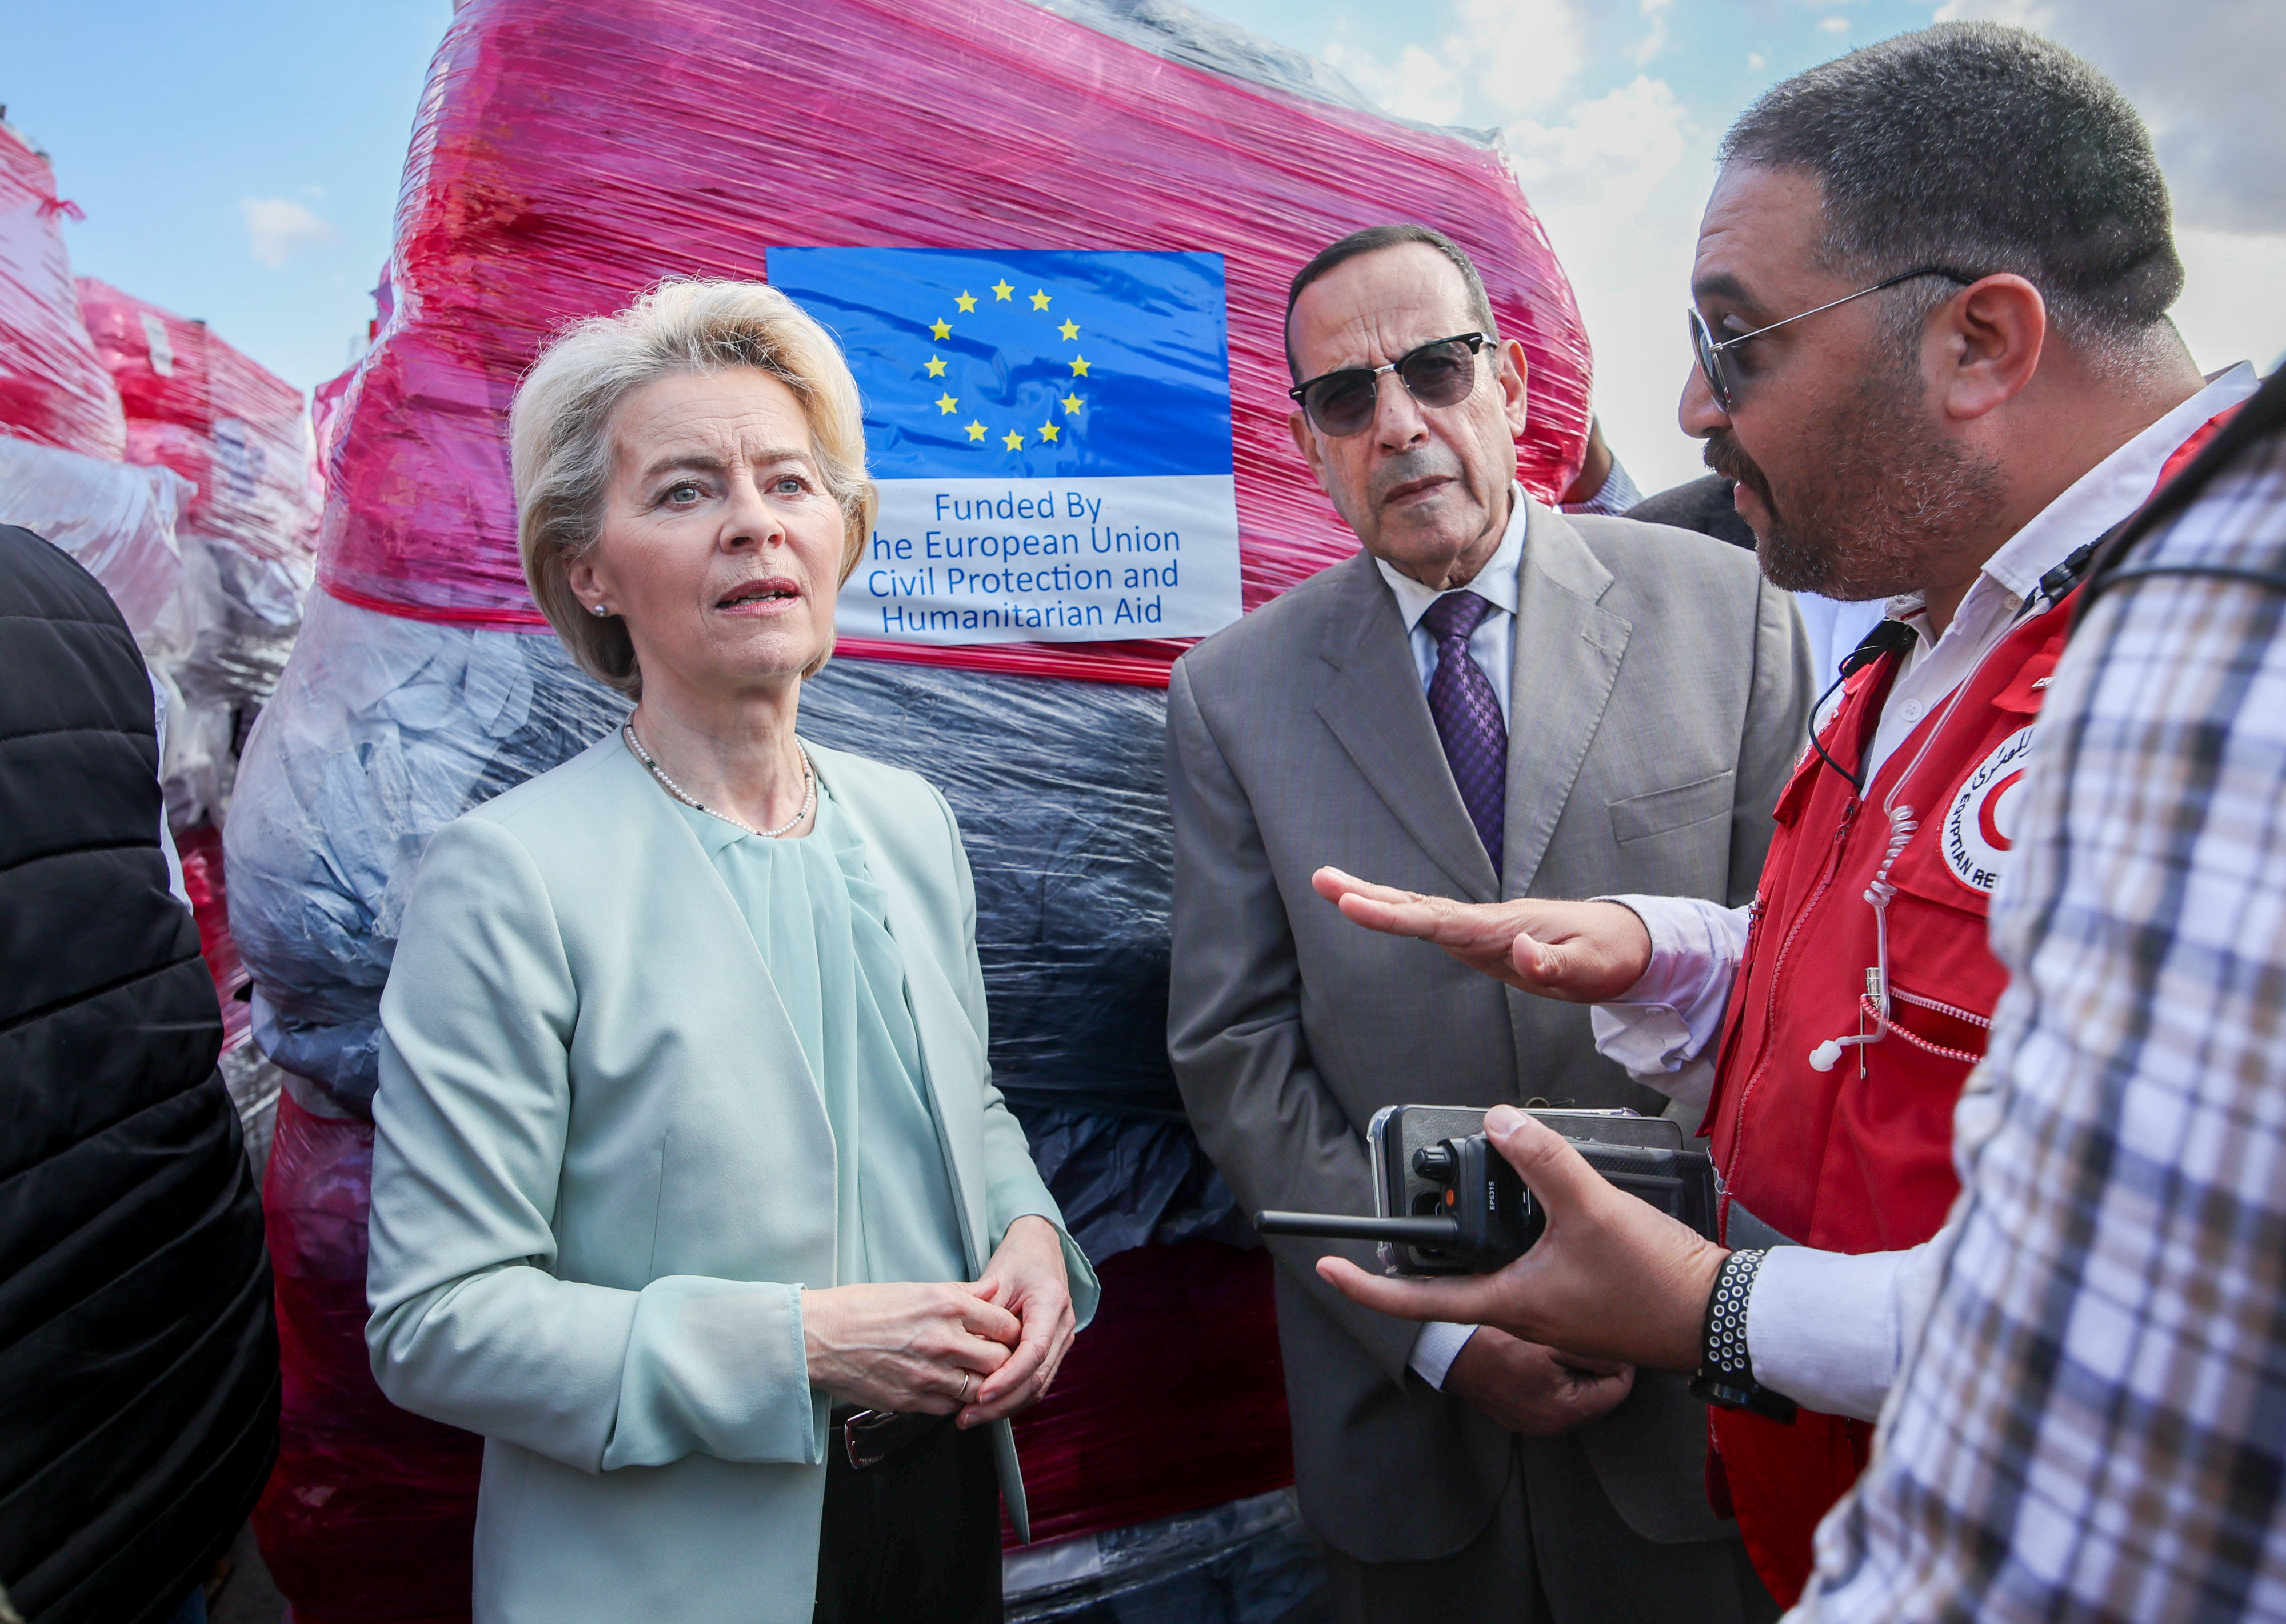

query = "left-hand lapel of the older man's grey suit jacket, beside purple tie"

[{"left": 1317, "top": 551, "right": 1513, "bottom": 901}]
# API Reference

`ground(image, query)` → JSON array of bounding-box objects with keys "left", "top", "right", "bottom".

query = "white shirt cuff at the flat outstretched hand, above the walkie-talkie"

[{"left": 1589, "top": 897, "right": 1747, "bottom": 1107}]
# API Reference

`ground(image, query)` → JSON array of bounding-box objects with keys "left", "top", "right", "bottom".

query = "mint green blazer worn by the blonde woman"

[{"left": 366, "top": 734, "right": 1097, "bottom": 1624}]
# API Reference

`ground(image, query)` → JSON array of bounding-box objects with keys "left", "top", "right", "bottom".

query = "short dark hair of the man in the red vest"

[{"left": 1721, "top": 23, "right": 2183, "bottom": 345}]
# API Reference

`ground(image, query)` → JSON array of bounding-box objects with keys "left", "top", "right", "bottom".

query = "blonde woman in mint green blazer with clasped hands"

[{"left": 366, "top": 281, "right": 1095, "bottom": 1624}]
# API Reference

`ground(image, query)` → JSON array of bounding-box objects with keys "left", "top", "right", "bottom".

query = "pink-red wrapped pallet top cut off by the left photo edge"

[{"left": 0, "top": 123, "right": 126, "bottom": 462}]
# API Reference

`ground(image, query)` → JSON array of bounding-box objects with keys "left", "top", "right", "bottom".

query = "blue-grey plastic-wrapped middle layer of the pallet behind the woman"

[{"left": 226, "top": 593, "right": 1250, "bottom": 1258}]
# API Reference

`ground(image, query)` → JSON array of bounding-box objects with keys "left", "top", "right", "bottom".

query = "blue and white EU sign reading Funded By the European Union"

[{"left": 768, "top": 247, "right": 1239, "bottom": 643}]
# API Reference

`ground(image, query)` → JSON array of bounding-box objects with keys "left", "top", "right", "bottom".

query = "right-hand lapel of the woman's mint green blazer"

[{"left": 802, "top": 739, "right": 990, "bottom": 1274}]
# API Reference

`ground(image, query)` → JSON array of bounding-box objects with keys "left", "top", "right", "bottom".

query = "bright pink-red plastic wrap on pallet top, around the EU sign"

[{"left": 320, "top": 0, "right": 1589, "bottom": 682}]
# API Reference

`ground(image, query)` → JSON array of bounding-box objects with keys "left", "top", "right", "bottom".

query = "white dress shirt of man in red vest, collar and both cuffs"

[{"left": 1591, "top": 361, "right": 2259, "bottom": 1421}]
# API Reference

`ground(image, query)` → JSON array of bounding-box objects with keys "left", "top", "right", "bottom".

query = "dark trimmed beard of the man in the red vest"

[{"left": 1705, "top": 363, "right": 2005, "bottom": 602}]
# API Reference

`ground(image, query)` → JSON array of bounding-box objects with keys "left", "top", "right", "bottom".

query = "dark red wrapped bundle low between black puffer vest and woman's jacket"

[{"left": 254, "top": 1095, "right": 485, "bottom": 1624}]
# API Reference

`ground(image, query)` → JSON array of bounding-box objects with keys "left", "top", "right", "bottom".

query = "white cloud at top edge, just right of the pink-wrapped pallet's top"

[{"left": 1324, "top": 0, "right": 1582, "bottom": 126}]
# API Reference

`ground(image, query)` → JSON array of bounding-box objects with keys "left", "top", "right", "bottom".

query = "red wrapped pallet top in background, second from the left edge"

[{"left": 80, "top": 277, "right": 318, "bottom": 571}]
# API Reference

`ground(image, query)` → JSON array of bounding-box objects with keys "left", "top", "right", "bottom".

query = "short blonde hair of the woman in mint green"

[{"left": 507, "top": 279, "right": 880, "bottom": 698}]
